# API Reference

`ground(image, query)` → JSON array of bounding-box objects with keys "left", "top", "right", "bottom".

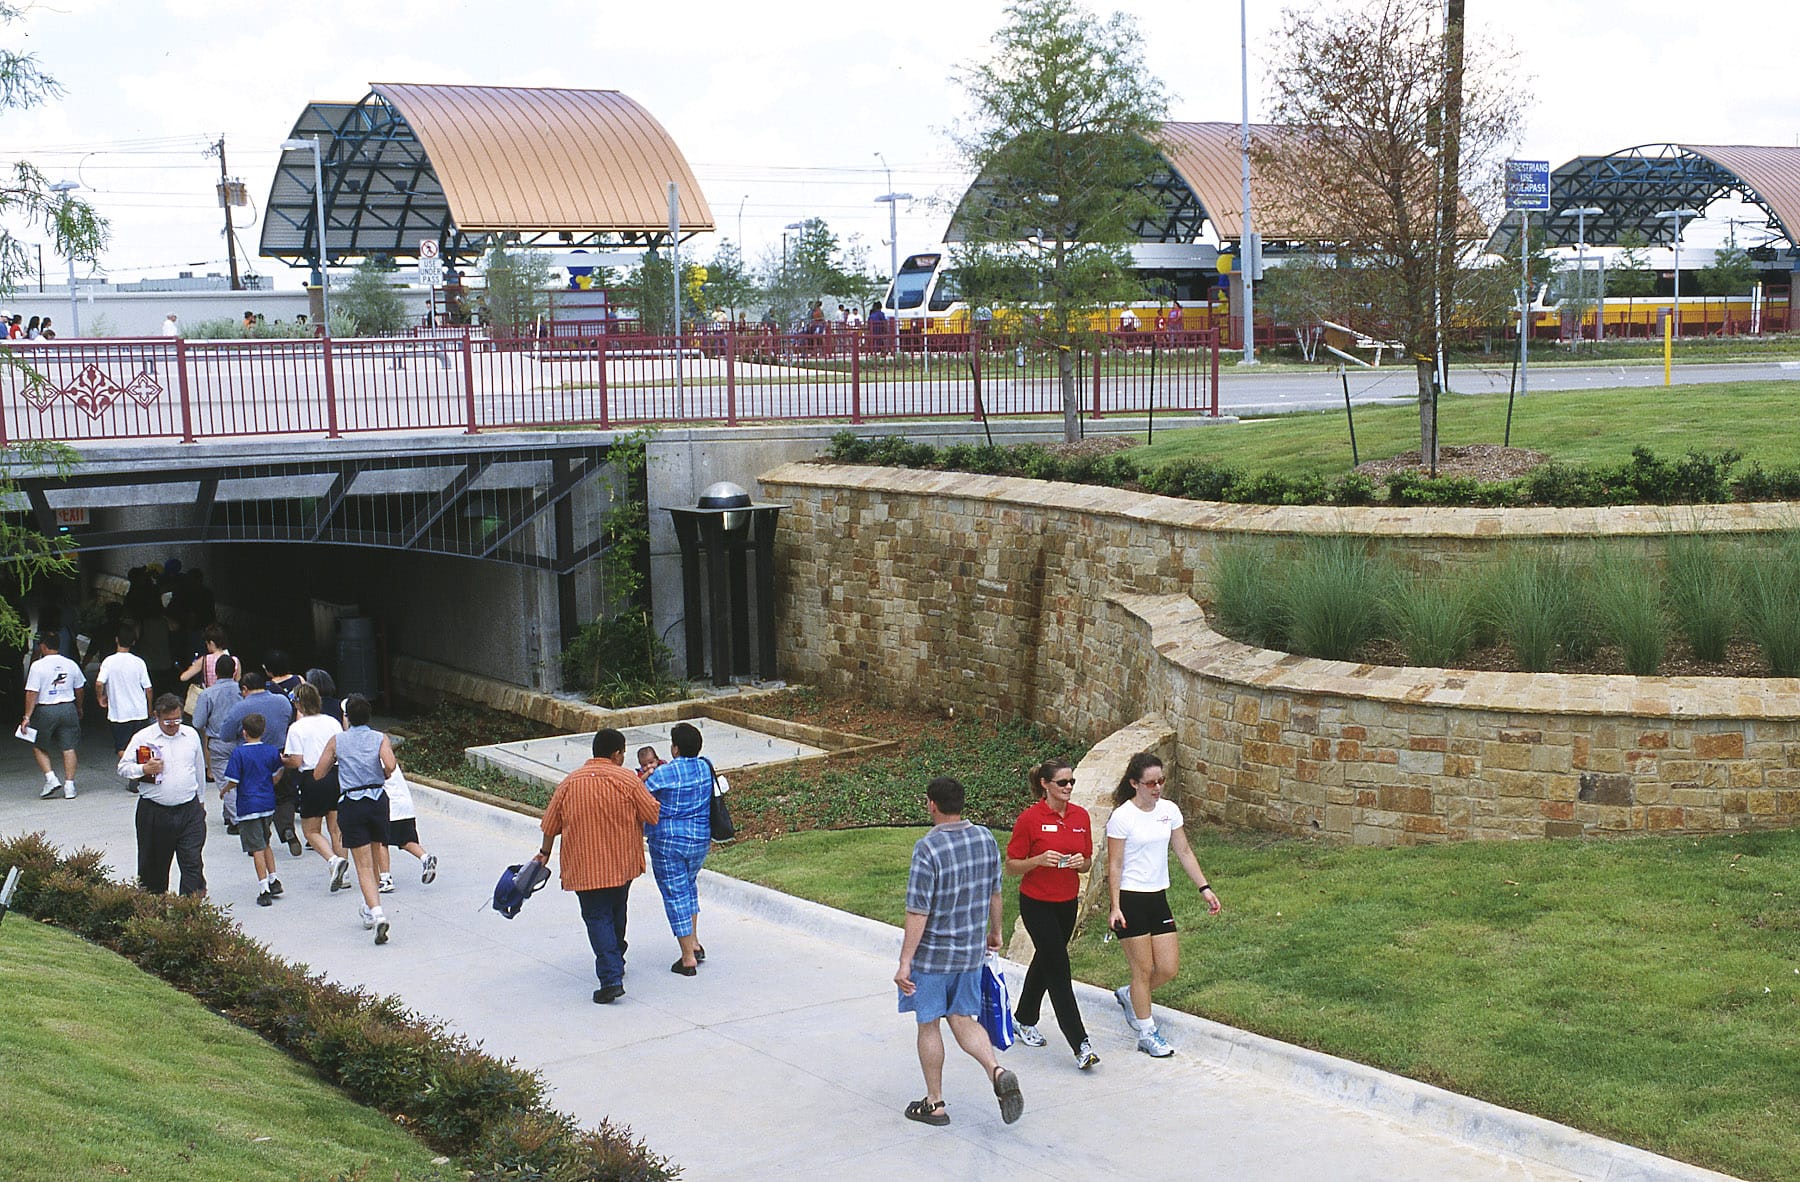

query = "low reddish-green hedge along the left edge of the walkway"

[{"left": 0, "top": 833, "right": 679, "bottom": 1182}]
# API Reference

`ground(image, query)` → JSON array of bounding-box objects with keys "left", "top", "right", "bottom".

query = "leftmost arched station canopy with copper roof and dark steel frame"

[{"left": 261, "top": 83, "right": 713, "bottom": 264}]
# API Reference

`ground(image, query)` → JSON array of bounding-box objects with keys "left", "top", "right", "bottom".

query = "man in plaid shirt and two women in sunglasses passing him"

[{"left": 895, "top": 752, "right": 1220, "bottom": 1124}]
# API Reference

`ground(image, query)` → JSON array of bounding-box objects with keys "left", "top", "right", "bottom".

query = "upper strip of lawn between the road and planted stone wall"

[{"left": 1132, "top": 371, "right": 1800, "bottom": 477}]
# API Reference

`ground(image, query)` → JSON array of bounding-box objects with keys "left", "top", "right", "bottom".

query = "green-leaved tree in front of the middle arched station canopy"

[{"left": 952, "top": 0, "right": 1168, "bottom": 443}]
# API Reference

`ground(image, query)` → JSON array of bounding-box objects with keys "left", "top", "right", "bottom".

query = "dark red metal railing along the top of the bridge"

[{"left": 0, "top": 329, "right": 1219, "bottom": 444}]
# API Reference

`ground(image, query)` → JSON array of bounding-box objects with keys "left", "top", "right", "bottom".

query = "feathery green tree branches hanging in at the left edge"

[{"left": 0, "top": 0, "right": 106, "bottom": 648}]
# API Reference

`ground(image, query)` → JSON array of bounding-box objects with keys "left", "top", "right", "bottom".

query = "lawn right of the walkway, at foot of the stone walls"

[{"left": 709, "top": 828, "right": 1800, "bottom": 1180}]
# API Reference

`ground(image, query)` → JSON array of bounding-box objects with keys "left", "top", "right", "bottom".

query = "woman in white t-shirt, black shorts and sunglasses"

[{"left": 1107, "top": 752, "right": 1219, "bottom": 1058}]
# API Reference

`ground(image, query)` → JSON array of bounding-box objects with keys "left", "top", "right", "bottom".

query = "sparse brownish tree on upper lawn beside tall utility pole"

[{"left": 1256, "top": 0, "right": 1523, "bottom": 457}]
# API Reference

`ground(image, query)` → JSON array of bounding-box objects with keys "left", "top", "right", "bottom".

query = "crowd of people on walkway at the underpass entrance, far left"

[{"left": 20, "top": 617, "right": 437, "bottom": 945}]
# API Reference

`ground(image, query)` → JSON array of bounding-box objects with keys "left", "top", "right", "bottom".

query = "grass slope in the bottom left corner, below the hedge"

[{"left": 0, "top": 914, "right": 439, "bottom": 1182}]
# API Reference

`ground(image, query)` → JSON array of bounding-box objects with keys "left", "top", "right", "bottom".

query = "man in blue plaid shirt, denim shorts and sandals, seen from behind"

[{"left": 895, "top": 775, "right": 1024, "bottom": 1124}]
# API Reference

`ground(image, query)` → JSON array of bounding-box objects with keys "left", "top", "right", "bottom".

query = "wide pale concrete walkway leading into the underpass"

[{"left": 0, "top": 727, "right": 1723, "bottom": 1182}]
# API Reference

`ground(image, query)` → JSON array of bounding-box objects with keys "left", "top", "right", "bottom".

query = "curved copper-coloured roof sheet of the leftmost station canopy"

[{"left": 371, "top": 83, "right": 713, "bottom": 232}]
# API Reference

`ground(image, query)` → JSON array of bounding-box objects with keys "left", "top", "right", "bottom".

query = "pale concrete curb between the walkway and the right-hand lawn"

[{"left": 414, "top": 783, "right": 1737, "bottom": 1182}]
